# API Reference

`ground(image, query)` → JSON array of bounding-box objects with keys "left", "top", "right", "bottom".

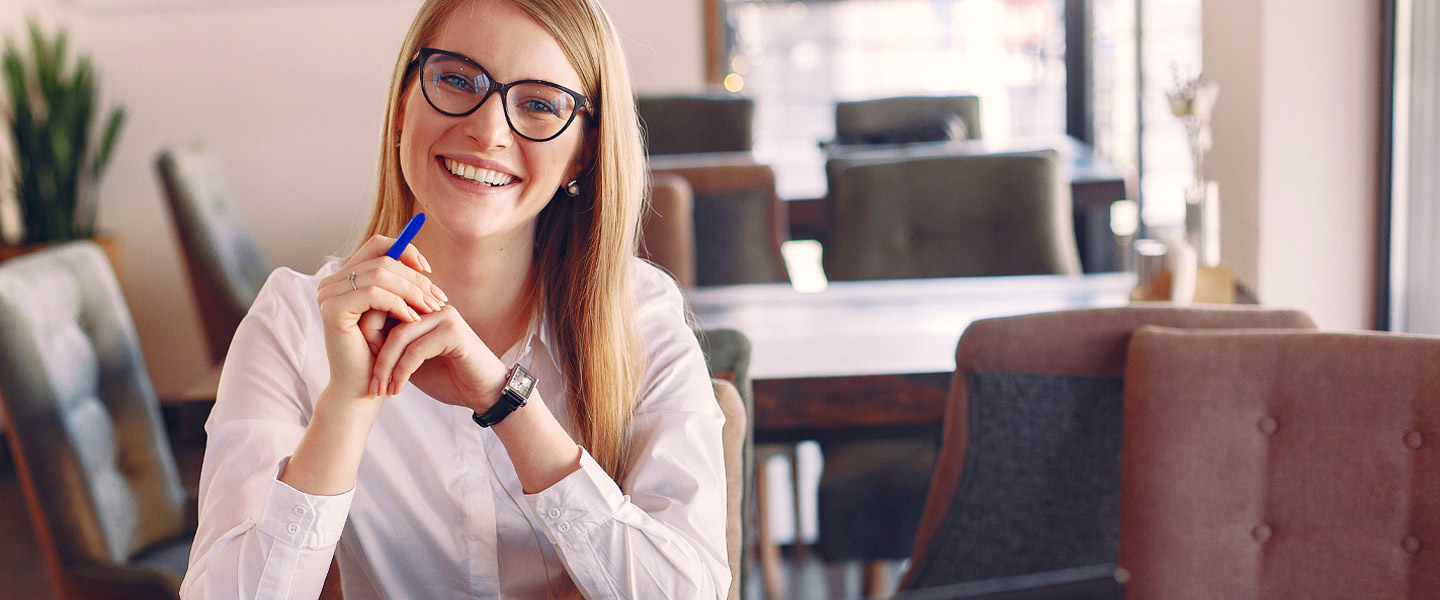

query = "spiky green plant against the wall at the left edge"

[{"left": 0, "top": 20, "right": 125, "bottom": 262}]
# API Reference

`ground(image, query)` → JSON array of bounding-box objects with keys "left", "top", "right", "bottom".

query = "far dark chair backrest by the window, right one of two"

[{"left": 835, "top": 96, "right": 981, "bottom": 144}]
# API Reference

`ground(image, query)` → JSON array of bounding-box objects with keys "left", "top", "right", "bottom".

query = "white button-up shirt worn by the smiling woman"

[{"left": 180, "top": 259, "right": 730, "bottom": 600}]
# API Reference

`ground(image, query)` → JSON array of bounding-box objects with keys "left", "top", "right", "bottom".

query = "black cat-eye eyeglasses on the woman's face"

[{"left": 410, "top": 47, "right": 589, "bottom": 141}]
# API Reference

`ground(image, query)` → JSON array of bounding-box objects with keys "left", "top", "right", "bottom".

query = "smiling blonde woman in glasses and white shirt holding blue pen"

[{"left": 181, "top": 0, "right": 730, "bottom": 599}]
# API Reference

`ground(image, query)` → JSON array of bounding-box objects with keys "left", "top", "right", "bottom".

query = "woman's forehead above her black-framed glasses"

[{"left": 431, "top": 0, "right": 580, "bottom": 89}]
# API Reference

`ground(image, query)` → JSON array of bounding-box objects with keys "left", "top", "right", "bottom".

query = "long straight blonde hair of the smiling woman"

[{"left": 364, "top": 0, "right": 645, "bottom": 482}]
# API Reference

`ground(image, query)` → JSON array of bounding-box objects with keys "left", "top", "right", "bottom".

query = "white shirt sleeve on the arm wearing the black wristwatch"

[{"left": 526, "top": 266, "right": 732, "bottom": 599}]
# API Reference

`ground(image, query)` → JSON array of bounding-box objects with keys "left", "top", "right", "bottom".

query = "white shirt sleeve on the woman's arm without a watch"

[{"left": 180, "top": 269, "right": 354, "bottom": 599}]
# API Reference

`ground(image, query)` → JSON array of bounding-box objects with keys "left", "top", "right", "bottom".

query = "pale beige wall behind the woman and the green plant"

[{"left": 0, "top": 0, "right": 703, "bottom": 394}]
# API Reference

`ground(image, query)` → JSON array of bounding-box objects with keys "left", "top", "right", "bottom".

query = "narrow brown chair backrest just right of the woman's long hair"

[{"left": 639, "top": 173, "right": 696, "bottom": 288}]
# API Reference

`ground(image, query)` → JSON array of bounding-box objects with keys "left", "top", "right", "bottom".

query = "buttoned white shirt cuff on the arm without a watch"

[{"left": 256, "top": 459, "right": 356, "bottom": 550}]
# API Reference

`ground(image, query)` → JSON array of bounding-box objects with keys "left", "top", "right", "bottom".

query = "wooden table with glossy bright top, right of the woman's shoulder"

[{"left": 685, "top": 273, "right": 1135, "bottom": 442}]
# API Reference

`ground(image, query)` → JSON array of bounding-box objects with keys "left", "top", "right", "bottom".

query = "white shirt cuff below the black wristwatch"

[{"left": 526, "top": 447, "right": 625, "bottom": 545}]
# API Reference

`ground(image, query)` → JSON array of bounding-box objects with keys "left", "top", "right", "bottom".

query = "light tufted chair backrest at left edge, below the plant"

[{"left": 0, "top": 242, "right": 189, "bottom": 593}]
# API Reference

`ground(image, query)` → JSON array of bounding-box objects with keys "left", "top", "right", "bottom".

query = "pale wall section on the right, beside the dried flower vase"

[{"left": 1204, "top": 0, "right": 1380, "bottom": 328}]
